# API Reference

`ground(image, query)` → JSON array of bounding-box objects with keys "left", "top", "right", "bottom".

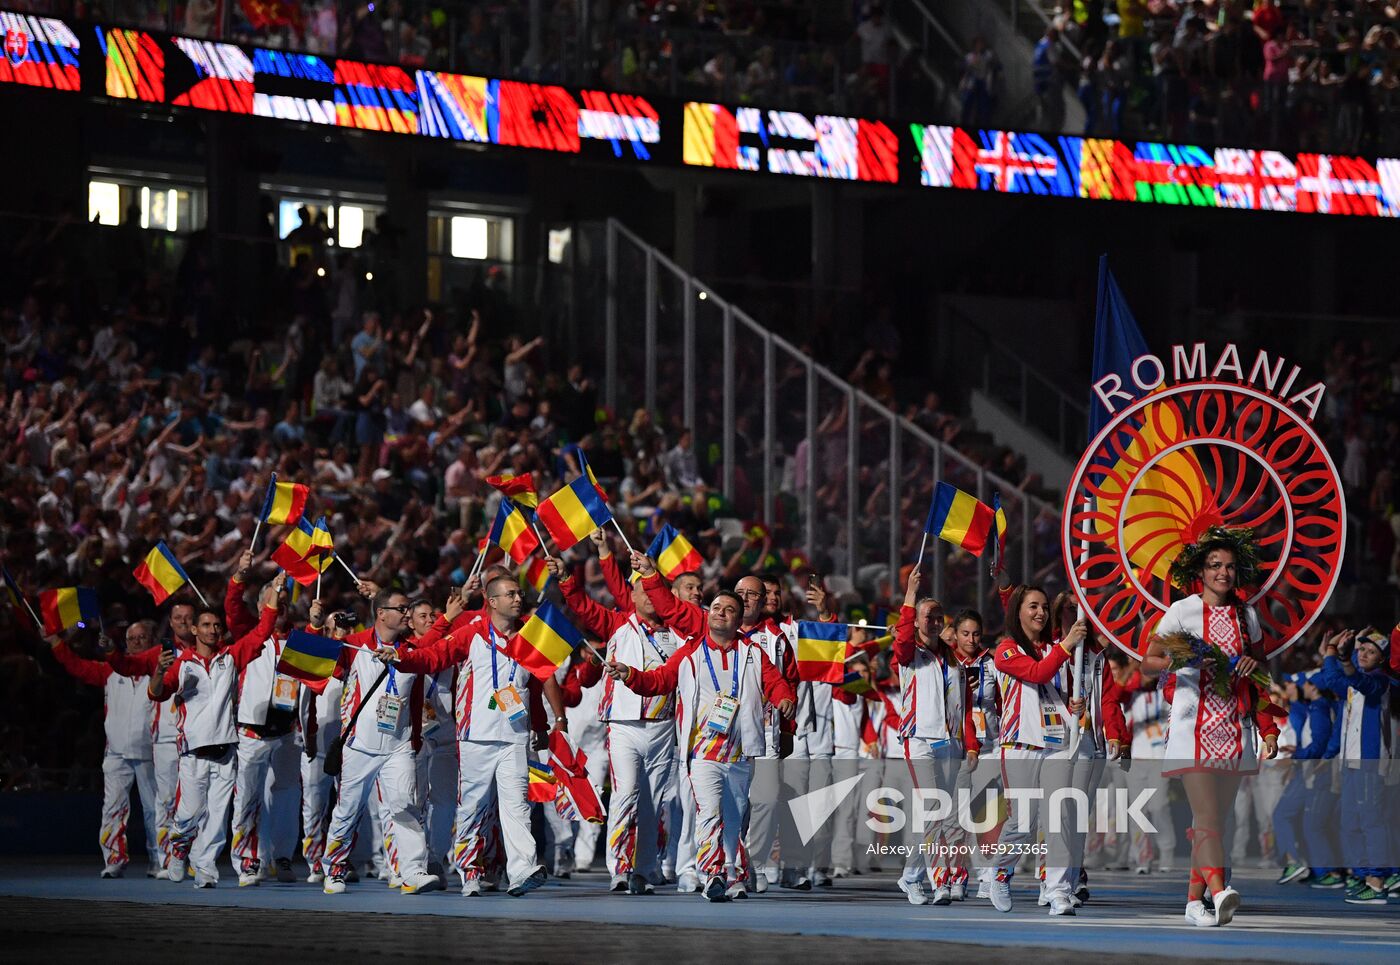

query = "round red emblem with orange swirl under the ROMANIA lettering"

[{"left": 1063, "top": 382, "right": 1347, "bottom": 657}]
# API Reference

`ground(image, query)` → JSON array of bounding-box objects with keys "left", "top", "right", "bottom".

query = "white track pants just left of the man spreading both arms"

[{"left": 608, "top": 720, "right": 676, "bottom": 882}]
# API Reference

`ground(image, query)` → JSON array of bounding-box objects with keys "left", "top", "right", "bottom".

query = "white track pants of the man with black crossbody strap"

[{"left": 322, "top": 745, "right": 428, "bottom": 877}]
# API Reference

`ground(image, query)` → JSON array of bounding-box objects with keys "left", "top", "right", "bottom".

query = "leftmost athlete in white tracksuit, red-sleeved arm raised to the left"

[{"left": 53, "top": 620, "right": 165, "bottom": 878}]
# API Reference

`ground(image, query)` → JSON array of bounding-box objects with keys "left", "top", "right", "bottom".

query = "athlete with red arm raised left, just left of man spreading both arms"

[{"left": 560, "top": 560, "right": 685, "bottom": 895}]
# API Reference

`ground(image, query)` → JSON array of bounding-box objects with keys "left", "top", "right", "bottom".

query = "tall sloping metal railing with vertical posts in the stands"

[{"left": 588, "top": 220, "right": 1063, "bottom": 629}]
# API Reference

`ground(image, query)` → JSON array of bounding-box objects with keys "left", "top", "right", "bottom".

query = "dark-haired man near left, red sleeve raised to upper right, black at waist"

[{"left": 148, "top": 602, "right": 283, "bottom": 888}]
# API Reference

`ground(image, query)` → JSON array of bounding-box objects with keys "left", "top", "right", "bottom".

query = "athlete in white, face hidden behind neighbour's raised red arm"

[{"left": 224, "top": 577, "right": 301, "bottom": 887}]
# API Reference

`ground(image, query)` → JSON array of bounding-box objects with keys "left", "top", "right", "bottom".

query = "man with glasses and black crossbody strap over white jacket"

[{"left": 322, "top": 590, "right": 441, "bottom": 895}]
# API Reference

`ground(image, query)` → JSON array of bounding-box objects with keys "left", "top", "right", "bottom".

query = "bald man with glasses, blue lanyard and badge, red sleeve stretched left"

[{"left": 381, "top": 576, "right": 564, "bottom": 898}]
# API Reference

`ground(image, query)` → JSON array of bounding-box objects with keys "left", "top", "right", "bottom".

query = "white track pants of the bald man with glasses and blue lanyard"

[{"left": 452, "top": 741, "right": 538, "bottom": 884}]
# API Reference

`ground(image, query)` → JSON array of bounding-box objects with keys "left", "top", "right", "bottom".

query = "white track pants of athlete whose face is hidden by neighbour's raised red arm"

[{"left": 231, "top": 734, "right": 301, "bottom": 870}]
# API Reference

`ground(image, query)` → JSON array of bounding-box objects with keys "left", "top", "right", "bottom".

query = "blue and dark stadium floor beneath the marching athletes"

[{"left": 0, "top": 859, "right": 1400, "bottom": 965}]
